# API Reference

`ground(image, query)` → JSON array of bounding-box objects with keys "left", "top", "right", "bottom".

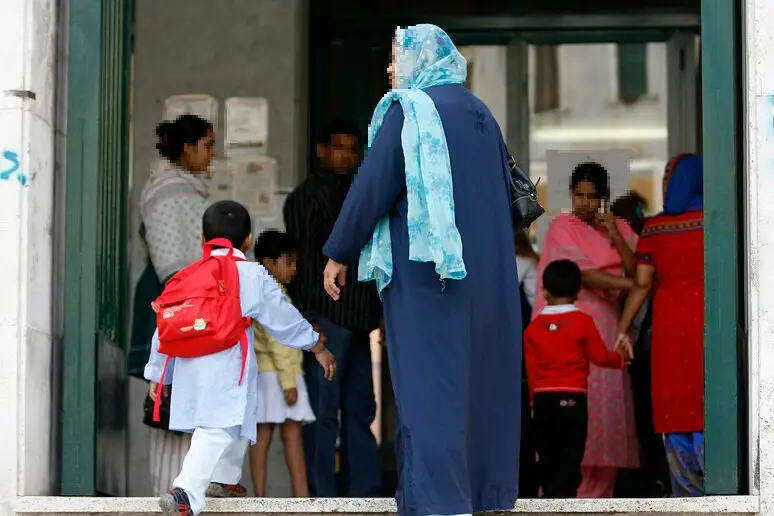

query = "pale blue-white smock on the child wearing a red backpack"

[{"left": 145, "top": 249, "right": 319, "bottom": 442}]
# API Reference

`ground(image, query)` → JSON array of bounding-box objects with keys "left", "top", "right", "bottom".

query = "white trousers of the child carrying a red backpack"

[{"left": 172, "top": 426, "right": 249, "bottom": 514}]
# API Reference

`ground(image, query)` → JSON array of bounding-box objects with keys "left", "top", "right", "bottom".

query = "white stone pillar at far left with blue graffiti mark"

[{"left": 0, "top": 0, "right": 57, "bottom": 514}]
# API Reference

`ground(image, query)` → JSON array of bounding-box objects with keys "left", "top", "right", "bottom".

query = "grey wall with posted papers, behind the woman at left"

[{"left": 129, "top": 0, "right": 308, "bottom": 496}]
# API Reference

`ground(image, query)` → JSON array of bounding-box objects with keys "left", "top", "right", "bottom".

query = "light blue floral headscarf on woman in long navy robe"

[{"left": 358, "top": 24, "right": 467, "bottom": 295}]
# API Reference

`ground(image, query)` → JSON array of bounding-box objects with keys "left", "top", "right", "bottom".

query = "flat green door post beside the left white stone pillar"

[{"left": 61, "top": 0, "right": 102, "bottom": 496}]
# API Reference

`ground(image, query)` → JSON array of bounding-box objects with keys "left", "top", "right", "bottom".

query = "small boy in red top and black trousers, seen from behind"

[{"left": 524, "top": 260, "right": 632, "bottom": 498}]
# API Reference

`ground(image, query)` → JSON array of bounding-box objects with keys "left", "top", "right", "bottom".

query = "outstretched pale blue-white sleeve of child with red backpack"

[{"left": 238, "top": 262, "right": 320, "bottom": 350}]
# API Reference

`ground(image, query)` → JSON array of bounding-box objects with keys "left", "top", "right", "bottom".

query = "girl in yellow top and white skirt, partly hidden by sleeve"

[{"left": 250, "top": 230, "right": 315, "bottom": 498}]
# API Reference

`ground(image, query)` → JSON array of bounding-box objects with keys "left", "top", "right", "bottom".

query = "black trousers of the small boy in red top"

[{"left": 534, "top": 392, "right": 589, "bottom": 498}]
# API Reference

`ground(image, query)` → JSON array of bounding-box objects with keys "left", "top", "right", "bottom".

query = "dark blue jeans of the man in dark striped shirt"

[{"left": 303, "top": 319, "right": 382, "bottom": 497}]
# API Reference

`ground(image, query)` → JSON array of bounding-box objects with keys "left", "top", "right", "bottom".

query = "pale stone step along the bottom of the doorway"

[{"left": 12, "top": 496, "right": 759, "bottom": 516}]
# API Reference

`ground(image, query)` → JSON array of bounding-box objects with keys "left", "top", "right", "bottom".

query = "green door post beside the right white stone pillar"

[{"left": 701, "top": 0, "right": 747, "bottom": 494}]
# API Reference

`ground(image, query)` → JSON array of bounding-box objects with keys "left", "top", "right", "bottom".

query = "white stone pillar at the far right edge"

[{"left": 742, "top": 0, "right": 774, "bottom": 508}]
